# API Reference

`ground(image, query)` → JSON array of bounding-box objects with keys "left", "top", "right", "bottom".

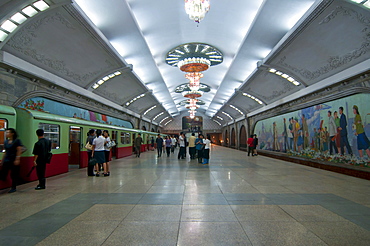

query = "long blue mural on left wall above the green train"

[{"left": 19, "top": 97, "right": 133, "bottom": 128}]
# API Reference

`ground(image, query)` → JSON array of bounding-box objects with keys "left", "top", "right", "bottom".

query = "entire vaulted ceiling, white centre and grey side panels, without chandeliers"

[{"left": 0, "top": 0, "right": 370, "bottom": 124}]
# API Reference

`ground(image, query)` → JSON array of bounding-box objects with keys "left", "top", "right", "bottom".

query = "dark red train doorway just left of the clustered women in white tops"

[{"left": 68, "top": 126, "right": 82, "bottom": 169}]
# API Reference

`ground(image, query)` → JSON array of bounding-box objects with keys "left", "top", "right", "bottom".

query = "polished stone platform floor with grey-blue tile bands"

[{"left": 0, "top": 146, "right": 370, "bottom": 246}]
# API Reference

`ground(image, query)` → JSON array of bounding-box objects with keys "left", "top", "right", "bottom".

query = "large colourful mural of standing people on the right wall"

[{"left": 254, "top": 94, "right": 370, "bottom": 167}]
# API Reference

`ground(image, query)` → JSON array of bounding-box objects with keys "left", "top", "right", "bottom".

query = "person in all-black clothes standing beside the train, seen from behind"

[{"left": 32, "top": 129, "right": 51, "bottom": 190}]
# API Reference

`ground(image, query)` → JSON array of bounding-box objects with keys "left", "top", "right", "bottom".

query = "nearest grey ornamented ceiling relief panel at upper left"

[{"left": 4, "top": 8, "right": 117, "bottom": 86}]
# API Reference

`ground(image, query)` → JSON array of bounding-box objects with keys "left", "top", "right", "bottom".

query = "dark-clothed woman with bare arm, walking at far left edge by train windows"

[{"left": 0, "top": 128, "right": 22, "bottom": 193}]
